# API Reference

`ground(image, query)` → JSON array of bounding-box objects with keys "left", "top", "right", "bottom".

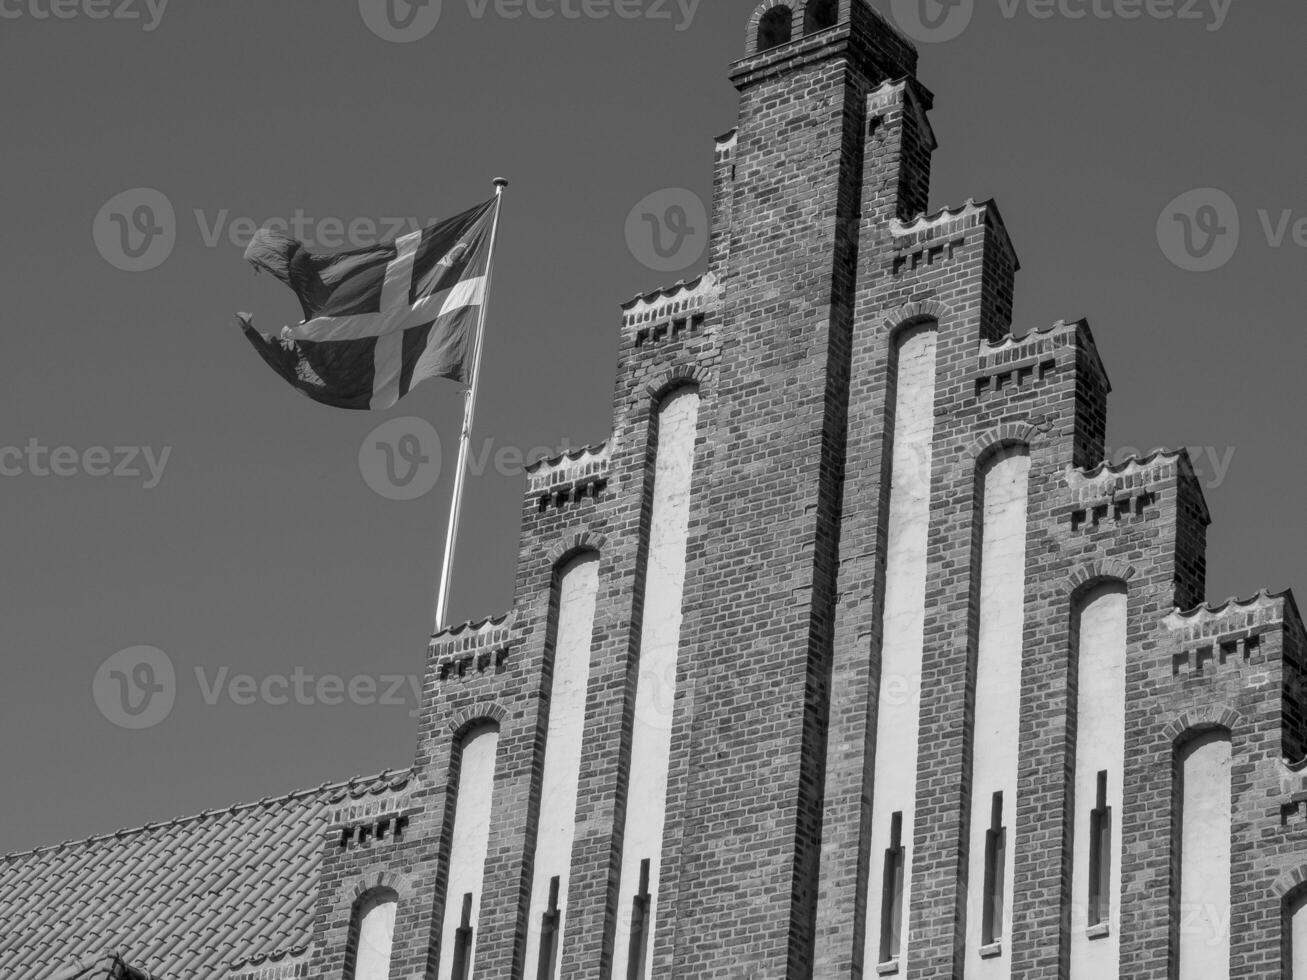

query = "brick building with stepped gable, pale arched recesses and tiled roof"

[{"left": 0, "top": 0, "right": 1307, "bottom": 980}]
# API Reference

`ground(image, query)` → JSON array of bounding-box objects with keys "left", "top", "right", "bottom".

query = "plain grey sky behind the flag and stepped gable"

[{"left": 0, "top": 0, "right": 1307, "bottom": 852}]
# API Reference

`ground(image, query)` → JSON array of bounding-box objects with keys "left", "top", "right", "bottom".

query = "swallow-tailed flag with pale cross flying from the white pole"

[{"left": 238, "top": 199, "right": 495, "bottom": 409}]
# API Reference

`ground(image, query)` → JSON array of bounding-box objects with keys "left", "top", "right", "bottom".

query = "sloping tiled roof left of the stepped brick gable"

[{"left": 0, "top": 771, "right": 409, "bottom": 980}]
